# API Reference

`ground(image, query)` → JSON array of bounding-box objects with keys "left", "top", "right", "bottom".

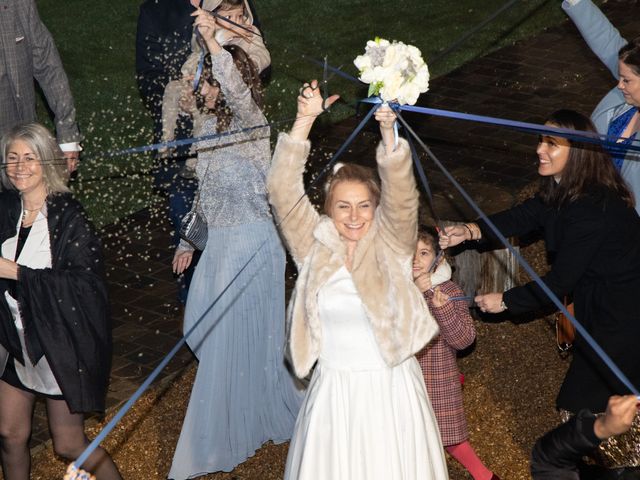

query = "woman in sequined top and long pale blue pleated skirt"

[{"left": 169, "top": 10, "right": 302, "bottom": 480}]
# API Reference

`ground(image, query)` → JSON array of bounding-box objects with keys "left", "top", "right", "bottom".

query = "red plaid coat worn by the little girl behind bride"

[{"left": 416, "top": 280, "right": 476, "bottom": 447}]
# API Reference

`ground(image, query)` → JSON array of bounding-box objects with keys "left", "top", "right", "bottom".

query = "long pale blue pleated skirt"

[{"left": 169, "top": 221, "right": 304, "bottom": 480}]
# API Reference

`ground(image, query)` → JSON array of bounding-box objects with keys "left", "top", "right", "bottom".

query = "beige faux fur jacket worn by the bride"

[{"left": 267, "top": 134, "right": 438, "bottom": 378}]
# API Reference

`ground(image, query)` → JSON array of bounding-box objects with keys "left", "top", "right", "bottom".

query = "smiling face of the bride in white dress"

[{"left": 329, "top": 181, "right": 376, "bottom": 242}]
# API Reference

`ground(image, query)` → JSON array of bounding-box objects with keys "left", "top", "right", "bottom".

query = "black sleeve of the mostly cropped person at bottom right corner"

[{"left": 531, "top": 410, "right": 600, "bottom": 480}]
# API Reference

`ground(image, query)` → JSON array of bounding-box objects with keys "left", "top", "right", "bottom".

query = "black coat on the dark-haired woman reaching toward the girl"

[{"left": 480, "top": 188, "right": 640, "bottom": 413}]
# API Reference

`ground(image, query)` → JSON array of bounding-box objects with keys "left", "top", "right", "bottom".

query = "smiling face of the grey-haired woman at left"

[{"left": 6, "top": 140, "right": 47, "bottom": 194}]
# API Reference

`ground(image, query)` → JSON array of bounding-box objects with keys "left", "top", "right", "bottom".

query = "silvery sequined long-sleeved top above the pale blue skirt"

[{"left": 190, "top": 50, "right": 271, "bottom": 233}]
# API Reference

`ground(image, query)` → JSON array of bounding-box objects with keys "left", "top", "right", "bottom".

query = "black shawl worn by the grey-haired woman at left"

[{"left": 0, "top": 191, "right": 111, "bottom": 413}]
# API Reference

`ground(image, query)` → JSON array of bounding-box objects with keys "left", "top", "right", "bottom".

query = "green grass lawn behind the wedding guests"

[{"left": 37, "top": 0, "right": 584, "bottom": 225}]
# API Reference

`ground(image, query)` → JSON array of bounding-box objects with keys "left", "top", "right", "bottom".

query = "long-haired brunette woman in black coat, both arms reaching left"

[{"left": 440, "top": 110, "right": 640, "bottom": 472}]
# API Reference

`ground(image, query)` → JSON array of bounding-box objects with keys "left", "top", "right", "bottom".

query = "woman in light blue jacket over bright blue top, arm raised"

[{"left": 562, "top": 0, "right": 640, "bottom": 213}]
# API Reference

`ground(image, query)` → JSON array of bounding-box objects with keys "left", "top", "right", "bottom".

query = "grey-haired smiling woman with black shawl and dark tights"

[{"left": 0, "top": 124, "right": 121, "bottom": 480}]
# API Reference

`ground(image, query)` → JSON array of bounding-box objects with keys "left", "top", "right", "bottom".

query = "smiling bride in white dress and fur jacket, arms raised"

[{"left": 268, "top": 81, "right": 448, "bottom": 480}]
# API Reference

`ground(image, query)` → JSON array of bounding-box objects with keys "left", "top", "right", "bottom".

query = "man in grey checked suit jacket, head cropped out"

[{"left": 0, "top": 0, "right": 82, "bottom": 172}]
